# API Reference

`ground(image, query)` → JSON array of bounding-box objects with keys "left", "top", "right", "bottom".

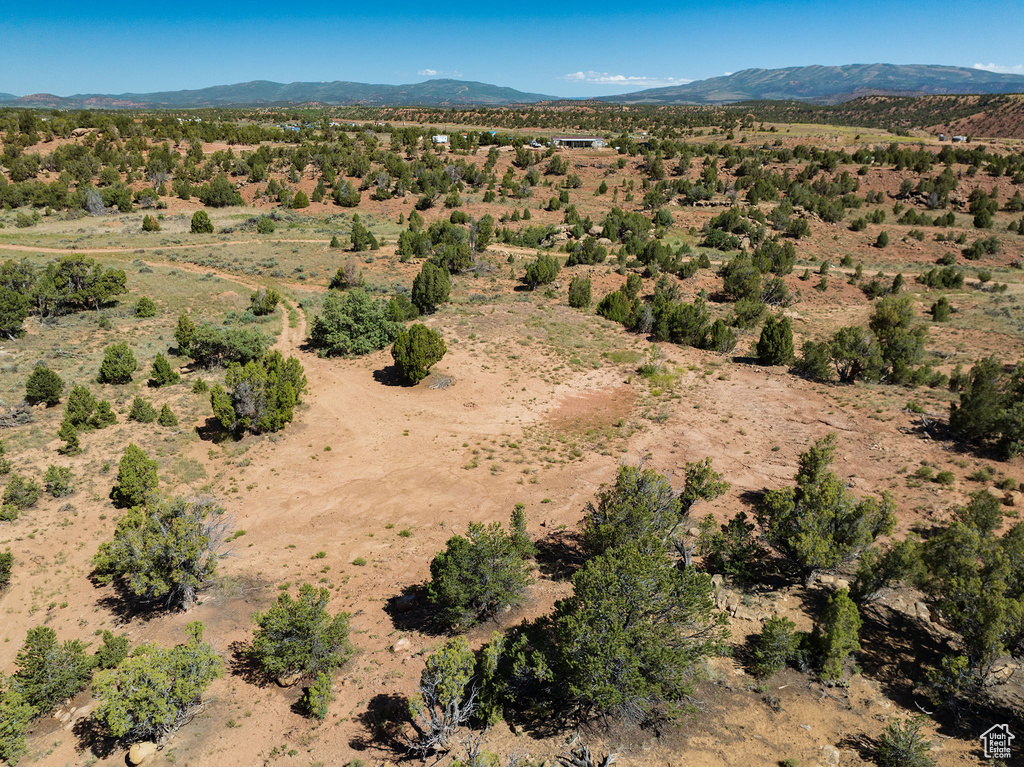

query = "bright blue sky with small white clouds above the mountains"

[{"left": 0, "top": 0, "right": 1024, "bottom": 96}]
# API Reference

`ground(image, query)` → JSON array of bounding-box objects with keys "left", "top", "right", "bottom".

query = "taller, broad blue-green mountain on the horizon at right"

[{"left": 601, "top": 63, "right": 1024, "bottom": 104}]
